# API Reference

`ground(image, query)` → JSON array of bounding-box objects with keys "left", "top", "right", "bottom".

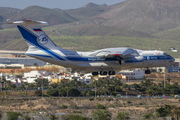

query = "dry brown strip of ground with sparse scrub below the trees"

[{"left": 0, "top": 98, "right": 179, "bottom": 119}]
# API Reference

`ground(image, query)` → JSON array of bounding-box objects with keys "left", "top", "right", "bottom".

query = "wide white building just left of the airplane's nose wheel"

[{"left": 116, "top": 70, "right": 145, "bottom": 80}]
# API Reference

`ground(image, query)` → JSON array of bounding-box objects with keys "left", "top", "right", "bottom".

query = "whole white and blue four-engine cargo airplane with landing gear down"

[{"left": 8, "top": 20, "right": 175, "bottom": 75}]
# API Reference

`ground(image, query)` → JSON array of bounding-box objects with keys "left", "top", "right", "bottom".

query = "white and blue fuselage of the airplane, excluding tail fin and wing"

[{"left": 26, "top": 48, "right": 174, "bottom": 72}]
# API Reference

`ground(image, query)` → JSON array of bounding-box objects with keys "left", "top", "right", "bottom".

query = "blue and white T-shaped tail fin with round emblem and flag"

[{"left": 7, "top": 20, "right": 59, "bottom": 49}]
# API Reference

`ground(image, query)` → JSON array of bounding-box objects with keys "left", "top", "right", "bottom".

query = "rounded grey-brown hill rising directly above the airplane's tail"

[{"left": 6, "top": 6, "right": 77, "bottom": 25}]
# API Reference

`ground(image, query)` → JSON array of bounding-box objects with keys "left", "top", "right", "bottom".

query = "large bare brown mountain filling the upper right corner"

[{"left": 99, "top": 0, "right": 180, "bottom": 33}]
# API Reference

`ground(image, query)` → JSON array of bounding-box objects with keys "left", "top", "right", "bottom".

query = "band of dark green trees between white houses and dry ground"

[{"left": 0, "top": 75, "right": 180, "bottom": 98}]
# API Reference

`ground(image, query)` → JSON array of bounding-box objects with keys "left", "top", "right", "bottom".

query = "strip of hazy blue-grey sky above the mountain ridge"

[{"left": 0, "top": 0, "right": 124, "bottom": 9}]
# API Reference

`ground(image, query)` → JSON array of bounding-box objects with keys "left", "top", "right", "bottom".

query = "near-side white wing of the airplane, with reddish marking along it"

[{"left": 96, "top": 48, "right": 134, "bottom": 58}]
